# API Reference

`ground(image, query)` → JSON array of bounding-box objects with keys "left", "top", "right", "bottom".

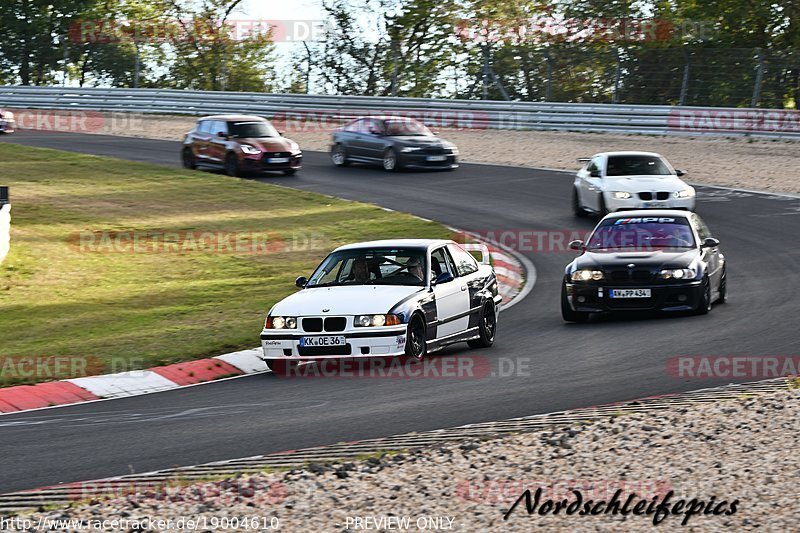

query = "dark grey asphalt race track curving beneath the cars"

[{"left": 0, "top": 132, "right": 800, "bottom": 492}]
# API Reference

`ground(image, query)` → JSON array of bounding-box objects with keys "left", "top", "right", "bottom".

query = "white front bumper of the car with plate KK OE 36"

[{"left": 261, "top": 324, "right": 406, "bottom": 361}]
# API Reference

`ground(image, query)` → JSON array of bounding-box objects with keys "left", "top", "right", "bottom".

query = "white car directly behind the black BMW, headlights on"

[{"left": 572, "top": 152, "right": 695, "bottom": 217}]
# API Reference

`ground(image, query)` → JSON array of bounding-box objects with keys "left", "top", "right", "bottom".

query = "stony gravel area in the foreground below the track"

[{"left": 7, "top": 389, "right": 800, "bottom": 532}]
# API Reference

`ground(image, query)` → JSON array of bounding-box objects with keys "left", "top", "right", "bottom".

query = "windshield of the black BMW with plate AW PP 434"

[{"left": 586, "top": 217, "right": 695, "bottom": 251}]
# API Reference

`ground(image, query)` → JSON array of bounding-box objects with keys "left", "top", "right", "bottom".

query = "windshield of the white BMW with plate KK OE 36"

[{"left": 307, "top": 248, "right": 427, "bottom": 287}]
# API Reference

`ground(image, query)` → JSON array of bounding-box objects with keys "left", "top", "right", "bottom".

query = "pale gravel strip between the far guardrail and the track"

[{"left": 25, "top": 113, "right": 800, "bottom": 193}]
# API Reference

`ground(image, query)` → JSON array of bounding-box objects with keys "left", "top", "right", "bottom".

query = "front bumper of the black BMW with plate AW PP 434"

[{"left": 565, "top": 280, "right": 703, "bottom": 313}]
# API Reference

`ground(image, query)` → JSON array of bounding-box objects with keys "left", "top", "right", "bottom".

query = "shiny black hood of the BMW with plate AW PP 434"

[{"left": 574, "top": 248, "right": 700, "bottom": 271}]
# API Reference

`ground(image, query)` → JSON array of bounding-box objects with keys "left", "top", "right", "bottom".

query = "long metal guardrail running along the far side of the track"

[{"left": 0, "top": 86, "right": 800, "bottom": 138}]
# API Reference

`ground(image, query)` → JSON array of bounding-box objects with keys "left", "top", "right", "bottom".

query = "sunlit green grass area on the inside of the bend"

[{"left": 0, "top": 144, "right": 450, "bottom": 386}]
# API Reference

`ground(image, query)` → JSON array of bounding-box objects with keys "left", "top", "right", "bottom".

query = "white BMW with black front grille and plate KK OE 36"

[{"left": 261, "top": 239, "right": 501, "bottom": 373}]
